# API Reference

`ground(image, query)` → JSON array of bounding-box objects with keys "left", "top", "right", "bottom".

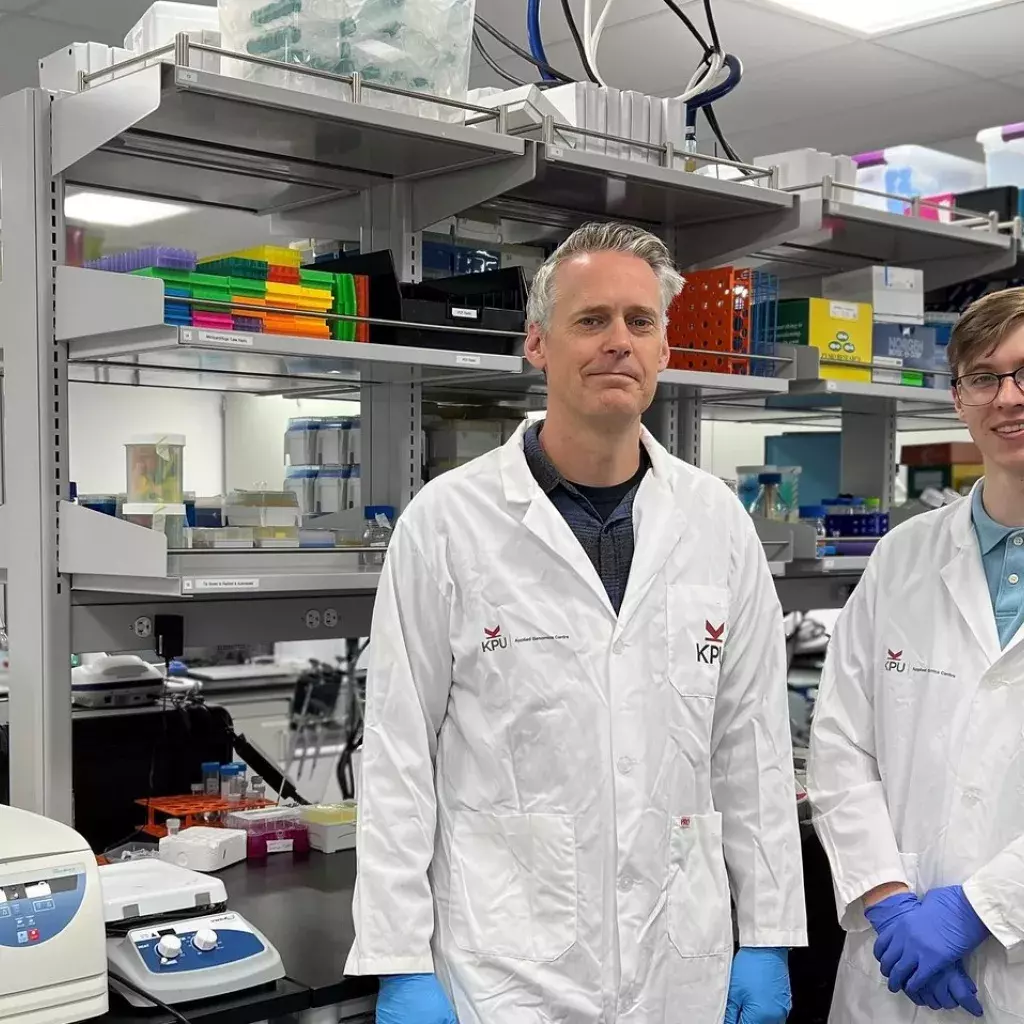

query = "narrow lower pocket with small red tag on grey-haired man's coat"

[{"left": 669, "top": 813, "right": 732, "bottom": 957}]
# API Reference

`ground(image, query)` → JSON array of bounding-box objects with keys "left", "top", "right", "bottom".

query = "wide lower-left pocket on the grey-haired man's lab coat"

[{"left": 449, "top": 812, "right": 577, "bottom": 963}]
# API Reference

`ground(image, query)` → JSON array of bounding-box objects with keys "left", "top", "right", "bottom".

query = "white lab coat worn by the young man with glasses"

[{"left": 808, "top": 489, "right": 1024, "bottom": 1024}]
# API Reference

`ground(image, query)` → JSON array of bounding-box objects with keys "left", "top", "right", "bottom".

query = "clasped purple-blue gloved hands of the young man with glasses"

[{"left": 864, "top": 886, "right": 988, "bottom": 1017}]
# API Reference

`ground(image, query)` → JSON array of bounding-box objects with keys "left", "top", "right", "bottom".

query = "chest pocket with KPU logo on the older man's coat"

[{"left": 666, "top": 583, "right": 729, "bottom": 697}]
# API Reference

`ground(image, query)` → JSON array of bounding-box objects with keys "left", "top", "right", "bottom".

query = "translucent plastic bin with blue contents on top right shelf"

[{"left": 840, "top": 145, "right": 985, "bottom": 214}]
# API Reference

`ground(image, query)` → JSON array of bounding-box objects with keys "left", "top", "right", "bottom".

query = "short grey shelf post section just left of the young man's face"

[{"left": 840, "top": 395, "right": 896, "bottom": 508}]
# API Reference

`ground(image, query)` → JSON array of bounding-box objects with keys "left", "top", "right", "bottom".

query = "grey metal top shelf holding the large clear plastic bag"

[{"left": 54, "top": 63, "right": 525, "bottom": 212}]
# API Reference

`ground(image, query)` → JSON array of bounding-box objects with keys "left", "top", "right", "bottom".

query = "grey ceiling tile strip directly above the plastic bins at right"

[{"left": 722, "top": 81, "right": 1022, "bottom": 160}]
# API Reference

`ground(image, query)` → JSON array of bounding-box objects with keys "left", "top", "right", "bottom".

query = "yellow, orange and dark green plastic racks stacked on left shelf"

[{"left": 199, "top": 246, "right": 336, "bottom": 338}]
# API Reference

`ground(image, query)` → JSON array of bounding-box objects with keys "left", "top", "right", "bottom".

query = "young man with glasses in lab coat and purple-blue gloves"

[{"left": 808, "top": 288, "right": 1024, "bottom": 1024}]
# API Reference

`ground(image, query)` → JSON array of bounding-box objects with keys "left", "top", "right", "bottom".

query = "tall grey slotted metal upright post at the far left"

[{"left": 0, "top": 89, "right": 73, "bottom": 822}]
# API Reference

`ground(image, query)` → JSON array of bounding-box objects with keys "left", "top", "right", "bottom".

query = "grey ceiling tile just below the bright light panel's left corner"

[{"left": 716, "top": 42, "right": 978, "bottom": 137}]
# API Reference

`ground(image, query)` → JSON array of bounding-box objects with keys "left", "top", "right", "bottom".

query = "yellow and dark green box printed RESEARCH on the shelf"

[{"left": 777, "top": 299, "right": 871, "bottom": 383}]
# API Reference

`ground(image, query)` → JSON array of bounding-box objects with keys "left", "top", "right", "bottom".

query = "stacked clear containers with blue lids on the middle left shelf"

[{"left": 285, "top": 416, "right": 362, "bottom": 516}]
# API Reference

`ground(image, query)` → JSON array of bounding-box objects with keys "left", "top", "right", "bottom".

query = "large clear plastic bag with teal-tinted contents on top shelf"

[{"left": 218, "top": 0, "right": 476, "bottom": 121}]
